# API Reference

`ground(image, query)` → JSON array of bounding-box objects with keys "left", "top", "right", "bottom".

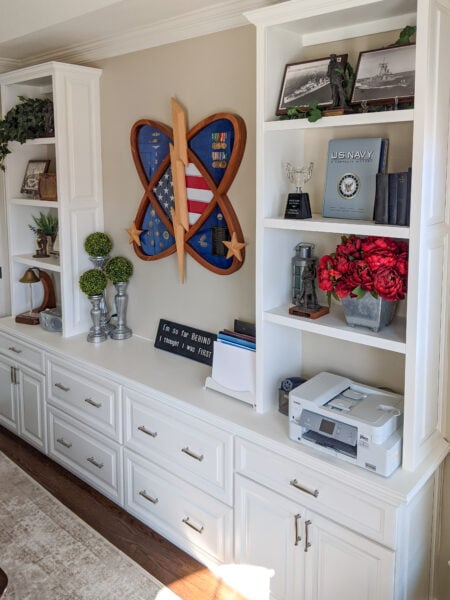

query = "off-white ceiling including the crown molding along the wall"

[{"left": 0, "top": 0, "right": 280, "bottom": 71}]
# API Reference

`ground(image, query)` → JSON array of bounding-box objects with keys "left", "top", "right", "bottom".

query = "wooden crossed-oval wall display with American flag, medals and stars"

[{"left": 128, "top": 99, "right": 246, "bottom": 281}]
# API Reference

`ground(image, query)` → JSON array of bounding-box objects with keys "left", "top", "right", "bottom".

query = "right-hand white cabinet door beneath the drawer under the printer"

[{"left": 305, "top": 512, "right": 395, "bottom": 600}]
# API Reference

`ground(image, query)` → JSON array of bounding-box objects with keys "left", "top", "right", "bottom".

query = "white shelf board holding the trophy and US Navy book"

[{"left": 264, "top": 214, "right": 410, "bottom": 239}]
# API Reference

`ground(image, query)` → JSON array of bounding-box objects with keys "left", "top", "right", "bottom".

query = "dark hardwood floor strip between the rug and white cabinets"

[{"left": 0, "top": 426, "right": 244, "bottom": 600}]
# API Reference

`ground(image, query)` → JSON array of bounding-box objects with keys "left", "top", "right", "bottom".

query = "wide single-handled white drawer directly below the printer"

[{"left": 236, "top": 438, "right": 396, "bottom": 547}]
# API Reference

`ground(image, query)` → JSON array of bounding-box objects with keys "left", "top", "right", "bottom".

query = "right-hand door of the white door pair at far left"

[{"left": 16, "top": 367, "right": 47, "bottom": 452}]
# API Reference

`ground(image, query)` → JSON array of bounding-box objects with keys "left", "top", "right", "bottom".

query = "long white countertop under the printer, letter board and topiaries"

[{"left": 0, "top": 317, "right": 448, "bottom": 505}]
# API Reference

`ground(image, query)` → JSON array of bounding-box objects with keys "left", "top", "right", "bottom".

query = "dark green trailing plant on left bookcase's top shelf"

[{"left": 0, "top": 96, "right": 55, "bottom": 171}]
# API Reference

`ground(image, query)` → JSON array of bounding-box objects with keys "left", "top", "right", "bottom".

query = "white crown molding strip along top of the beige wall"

[{"left": 5, "top": 0, "right": 274, "bottom": 68}]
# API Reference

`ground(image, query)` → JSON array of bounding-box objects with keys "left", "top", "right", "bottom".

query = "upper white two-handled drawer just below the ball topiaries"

[{"left": 48, "top": 359, "right": 122, "bottom": 442}]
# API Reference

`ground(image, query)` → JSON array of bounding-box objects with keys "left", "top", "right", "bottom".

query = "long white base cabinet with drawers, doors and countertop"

[{"left": 0, "top": 324, "right": 447, "bottom": 600}]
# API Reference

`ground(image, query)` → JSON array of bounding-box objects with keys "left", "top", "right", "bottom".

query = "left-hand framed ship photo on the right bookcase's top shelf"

[{"left": 276, "top": 54, "right": 347, "bottom": 115}]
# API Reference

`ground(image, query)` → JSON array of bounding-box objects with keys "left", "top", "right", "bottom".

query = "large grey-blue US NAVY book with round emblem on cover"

[{"left": 322, "top": 138, "right": 388, "bottom": 221}]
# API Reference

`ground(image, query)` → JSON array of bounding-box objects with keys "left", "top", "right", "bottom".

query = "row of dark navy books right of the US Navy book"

[{"left": 373, "top": 168, "right": 411, "bottom": 225}]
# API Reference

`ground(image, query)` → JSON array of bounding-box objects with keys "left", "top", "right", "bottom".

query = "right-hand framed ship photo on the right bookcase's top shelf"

[{"left": 350, "top": 44, "right": 416, "bottom": 104}]
